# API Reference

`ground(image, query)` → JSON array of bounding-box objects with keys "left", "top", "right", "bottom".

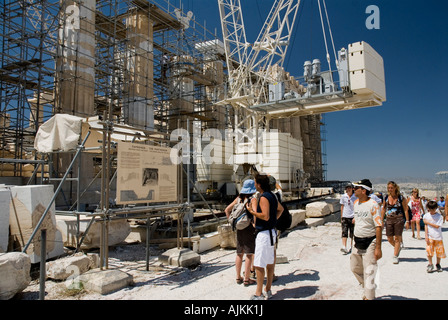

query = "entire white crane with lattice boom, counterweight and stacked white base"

[{"left": 218, "top": 0, "right": 386, "bottom": 188}]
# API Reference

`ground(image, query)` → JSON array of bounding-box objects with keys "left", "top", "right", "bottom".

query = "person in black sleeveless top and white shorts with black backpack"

[{"left": 246, "top": 174, "right": 283, "bottom": 300}]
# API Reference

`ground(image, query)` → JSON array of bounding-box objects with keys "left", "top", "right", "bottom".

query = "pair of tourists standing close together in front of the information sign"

[{"left": 225, "top": 174, "right": 284, "bottom": 300}]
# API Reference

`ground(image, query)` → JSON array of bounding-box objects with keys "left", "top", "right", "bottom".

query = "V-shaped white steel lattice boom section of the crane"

[{"left": 218, "top": 0, "right": 300, "bottom": 107}]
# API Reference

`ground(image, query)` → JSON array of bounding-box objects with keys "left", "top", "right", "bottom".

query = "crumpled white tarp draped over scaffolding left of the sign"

[{"left": 34, "top": 113, "right": 83, "bottom": 152}]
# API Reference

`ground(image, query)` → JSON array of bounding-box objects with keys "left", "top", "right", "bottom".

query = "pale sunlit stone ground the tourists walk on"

[{"left": 14, "top": 222, "right": 448, "bottom": 301}]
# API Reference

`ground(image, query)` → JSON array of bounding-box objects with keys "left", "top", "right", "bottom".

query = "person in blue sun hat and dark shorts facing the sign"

[{"left": 225, "top": 179, "right": 257, "bottom": 286}]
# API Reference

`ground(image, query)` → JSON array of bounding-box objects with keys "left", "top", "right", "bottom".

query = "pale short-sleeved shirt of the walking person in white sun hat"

[{"left": 354, "top": 198, "right": 382, "bottom": 238}]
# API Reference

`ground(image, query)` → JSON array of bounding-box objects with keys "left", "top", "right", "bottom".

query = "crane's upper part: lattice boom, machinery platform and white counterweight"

[{"left": 218, "top": 0, "right": 386, "bottom": 119}]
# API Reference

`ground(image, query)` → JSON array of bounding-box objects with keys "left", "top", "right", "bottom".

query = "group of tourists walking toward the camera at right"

[{"left": 340, "top": 179, "right": 447, "bottom": 300}]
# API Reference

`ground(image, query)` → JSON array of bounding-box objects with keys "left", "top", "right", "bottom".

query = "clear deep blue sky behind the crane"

[{"left": 182, "top": 0, "right": 448, "bottom": 180}]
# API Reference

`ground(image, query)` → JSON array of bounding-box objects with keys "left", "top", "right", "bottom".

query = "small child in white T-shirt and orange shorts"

[{"left": 423, "top": 201, "right": 446, "bottom": 272}]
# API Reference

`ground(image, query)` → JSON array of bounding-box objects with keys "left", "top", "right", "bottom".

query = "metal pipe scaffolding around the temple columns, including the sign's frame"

[{"left": 0, "top": 0, "right": 330, "bottom": 267}]
